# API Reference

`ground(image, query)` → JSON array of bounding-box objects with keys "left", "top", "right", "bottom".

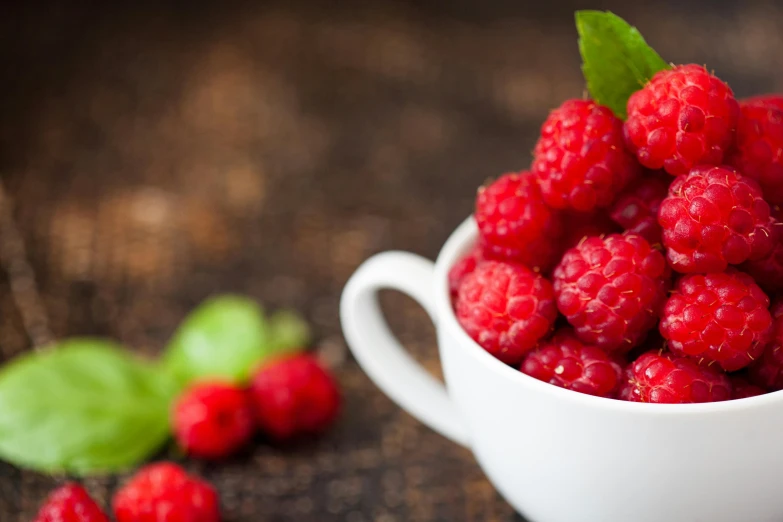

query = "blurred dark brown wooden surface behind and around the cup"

[{"left": 0, "top": 0, "right": 783, "bottom": 522}]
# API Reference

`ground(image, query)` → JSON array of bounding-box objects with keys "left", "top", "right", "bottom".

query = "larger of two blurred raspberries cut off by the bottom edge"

[{"left": 112, "top": 462, "right": 220, "bottom": 522}]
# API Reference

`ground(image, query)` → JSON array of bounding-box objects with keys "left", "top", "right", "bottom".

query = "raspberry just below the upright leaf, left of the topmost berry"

[{"left": 531, "top": 100, "right": 639, "bottom": 212}]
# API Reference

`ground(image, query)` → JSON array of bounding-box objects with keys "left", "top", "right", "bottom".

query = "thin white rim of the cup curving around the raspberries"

[{"left": 434, "top": 215, "right": 783, "bottom": 416}]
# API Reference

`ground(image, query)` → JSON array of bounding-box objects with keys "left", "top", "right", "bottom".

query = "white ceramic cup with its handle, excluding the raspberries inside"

[{"left": 340, "top": 214, "right": 783, "bottom": 522}]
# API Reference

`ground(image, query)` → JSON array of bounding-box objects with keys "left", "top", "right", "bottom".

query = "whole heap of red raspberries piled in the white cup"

[{"left": 449, "top": 65, "right": 783, "bottom": 403}]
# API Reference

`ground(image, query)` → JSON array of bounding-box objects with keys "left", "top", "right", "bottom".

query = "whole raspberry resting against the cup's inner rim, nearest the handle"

[{"left": 456, "top": 261, "right": 557, "bottom": 364}]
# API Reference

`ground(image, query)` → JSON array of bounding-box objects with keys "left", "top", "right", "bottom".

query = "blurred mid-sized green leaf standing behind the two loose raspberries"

[{"left": 164, "top": 295, "right": 268, "bottom": 385}]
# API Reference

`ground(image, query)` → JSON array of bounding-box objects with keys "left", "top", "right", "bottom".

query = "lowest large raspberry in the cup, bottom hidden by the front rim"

[{"left": 619, "top": 352, "right": 731, "bottom": 404}]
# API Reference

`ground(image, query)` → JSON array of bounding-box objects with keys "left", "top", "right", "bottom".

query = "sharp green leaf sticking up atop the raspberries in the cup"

[{"left": 576, "top": 11, "right": 669, "bottom": 119}]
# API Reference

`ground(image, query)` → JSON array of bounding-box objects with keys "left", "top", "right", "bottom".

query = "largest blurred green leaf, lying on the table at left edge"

[{"left": 0, "top": 339, "right": 176, "bottom": 475}]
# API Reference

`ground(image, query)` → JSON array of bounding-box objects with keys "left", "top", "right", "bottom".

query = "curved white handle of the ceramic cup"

[{"left": 340, "top": 252, "right": 468, "bottom": 446}]
